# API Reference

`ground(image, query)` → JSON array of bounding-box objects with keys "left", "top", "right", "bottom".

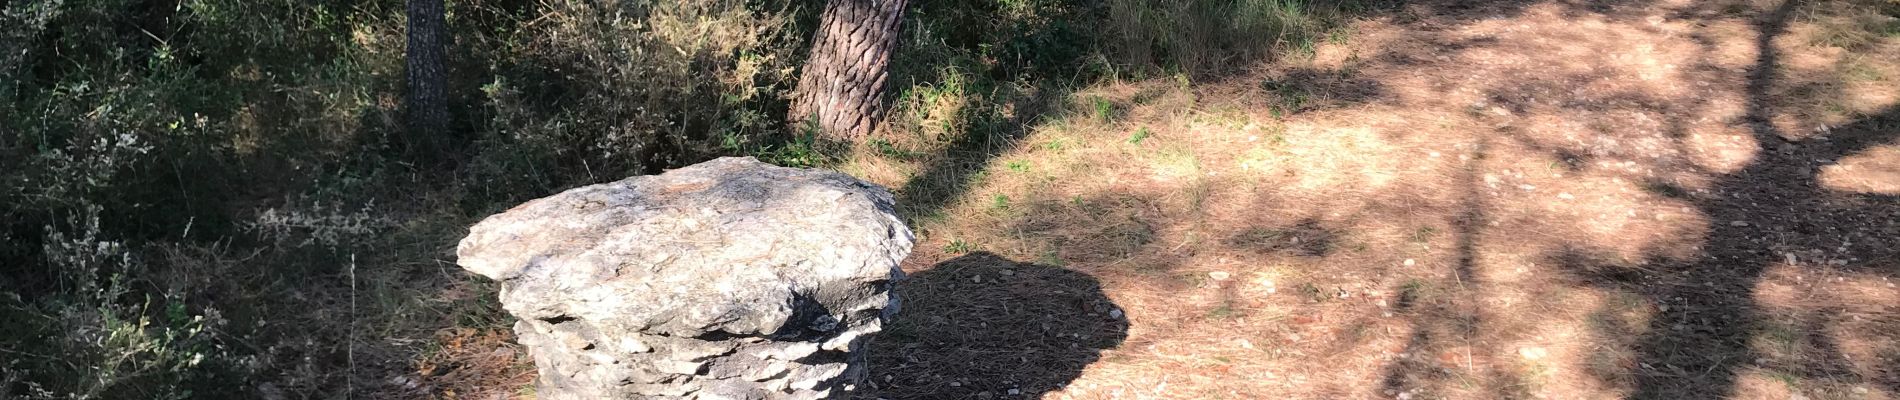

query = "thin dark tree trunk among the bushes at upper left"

[{"left": 403, "top": 0, "right": 448, "bottom": 157}]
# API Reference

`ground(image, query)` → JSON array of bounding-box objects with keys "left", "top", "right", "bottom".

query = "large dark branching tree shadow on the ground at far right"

[{"left": 1549, "top": 0, "right": 1900, "bottom": 398}]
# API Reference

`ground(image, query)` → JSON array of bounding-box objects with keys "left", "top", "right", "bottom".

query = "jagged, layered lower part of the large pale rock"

[{"left": 515, "top": 300, "right": 895, "bottom": 400}]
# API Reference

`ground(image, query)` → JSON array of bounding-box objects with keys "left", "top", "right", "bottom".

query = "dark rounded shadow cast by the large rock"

[{"left": 865, "top": 252, "right": 1129, "bottom": 398}]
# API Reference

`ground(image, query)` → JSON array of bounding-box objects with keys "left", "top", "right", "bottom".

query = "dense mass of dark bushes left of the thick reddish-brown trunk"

[{"left": 0, "top": 0, "right": 815, "bottom": 398}]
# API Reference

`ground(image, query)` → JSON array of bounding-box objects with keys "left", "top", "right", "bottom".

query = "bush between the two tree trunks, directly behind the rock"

[{"left": 477, "top": 0, "right": 802, "bottom": 193}]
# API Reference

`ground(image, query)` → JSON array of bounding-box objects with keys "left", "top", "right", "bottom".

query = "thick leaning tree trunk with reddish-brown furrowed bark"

[{"left": 789, "top": 0, "right": 906, "bottom": 140}]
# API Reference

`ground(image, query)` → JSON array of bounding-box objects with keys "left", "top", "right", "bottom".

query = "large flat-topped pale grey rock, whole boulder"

[{"left": 456, "top": 157, "right": 912, "bottom": 400}]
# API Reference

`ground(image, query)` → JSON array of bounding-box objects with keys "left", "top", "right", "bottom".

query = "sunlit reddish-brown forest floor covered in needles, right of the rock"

[{"left": 419, "top": 0, "right": 1900, "bottom": 400}]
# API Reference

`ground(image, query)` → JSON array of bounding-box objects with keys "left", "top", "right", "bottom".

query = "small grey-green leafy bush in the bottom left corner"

[{"left": 0, "top": 207, "right": 222, "bottom": 398}]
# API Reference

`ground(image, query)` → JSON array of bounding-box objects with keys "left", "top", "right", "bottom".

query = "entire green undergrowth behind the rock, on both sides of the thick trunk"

[{"left": 0, "top": 0, "right": 1364, "bottom": 398}]
